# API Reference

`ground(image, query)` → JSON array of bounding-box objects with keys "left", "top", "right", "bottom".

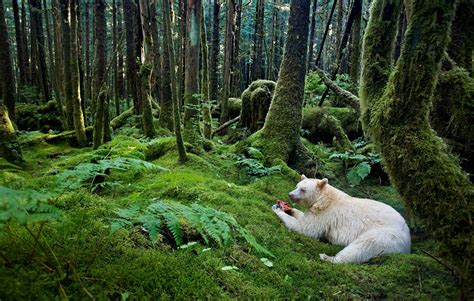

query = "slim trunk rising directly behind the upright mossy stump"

[{"left": 251, "top": 0, "right": 265, "bottom": 81}]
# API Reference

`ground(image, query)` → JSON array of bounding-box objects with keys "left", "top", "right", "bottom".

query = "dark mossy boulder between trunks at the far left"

[{"left": 15, "top": 101, "right": 63, "bottom": 133}]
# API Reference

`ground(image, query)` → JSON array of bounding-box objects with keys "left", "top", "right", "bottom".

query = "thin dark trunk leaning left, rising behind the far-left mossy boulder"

[{"left": 29, "top": 0, "right": 50, "bottom": 102}]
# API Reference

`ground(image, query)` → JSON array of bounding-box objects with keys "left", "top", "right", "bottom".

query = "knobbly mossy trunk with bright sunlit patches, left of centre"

[{"left": 140, "top": 0, "right": 156, "bottom": 137}]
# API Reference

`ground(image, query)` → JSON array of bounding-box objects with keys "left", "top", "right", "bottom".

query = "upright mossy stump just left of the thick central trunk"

[{"left": 240, "top": 80, "right": 275, "bottom": 133}]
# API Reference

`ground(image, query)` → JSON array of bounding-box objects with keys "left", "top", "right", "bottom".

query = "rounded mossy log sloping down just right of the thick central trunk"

[{"left": 301, "top": 107, "right": 353, "bottom": 150}]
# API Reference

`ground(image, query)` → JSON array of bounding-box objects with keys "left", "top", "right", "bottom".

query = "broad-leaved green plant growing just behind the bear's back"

[{"left": 329, "top": 139, "right": 381, "bottom": 186}]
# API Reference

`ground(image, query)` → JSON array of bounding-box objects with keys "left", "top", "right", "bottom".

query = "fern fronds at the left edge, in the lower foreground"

[{"left": 0, "top": 186, "right": 62, "bottom": 230}]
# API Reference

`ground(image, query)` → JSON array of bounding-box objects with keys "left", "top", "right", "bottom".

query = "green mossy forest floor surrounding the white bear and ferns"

[{"left": 0, "top": 133, "right": 458, "bottom": 300}]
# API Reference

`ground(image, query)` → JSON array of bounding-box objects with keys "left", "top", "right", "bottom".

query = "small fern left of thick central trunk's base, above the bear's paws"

[{"left": 235, "top": 147, "right": 281, "bottom": 181}]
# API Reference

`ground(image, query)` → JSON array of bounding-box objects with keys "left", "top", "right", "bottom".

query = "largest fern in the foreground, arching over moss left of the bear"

[{"left": 111, "top": 199, "right": 275, "bottom": 257}]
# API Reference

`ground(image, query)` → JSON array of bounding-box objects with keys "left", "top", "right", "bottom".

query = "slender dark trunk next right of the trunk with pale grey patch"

[{"left": 209, "top": 0, "right": 220, "bottom": 101}]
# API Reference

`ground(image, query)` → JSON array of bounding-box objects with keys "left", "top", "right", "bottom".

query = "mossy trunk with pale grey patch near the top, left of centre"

[{"left": 183, "top": 0, "right": 202, "bottom": 144}]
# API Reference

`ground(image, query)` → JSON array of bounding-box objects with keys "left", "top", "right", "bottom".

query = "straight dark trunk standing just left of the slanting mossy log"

[{"left": 93, "top": 0, "right": 107, "bottom": 149}]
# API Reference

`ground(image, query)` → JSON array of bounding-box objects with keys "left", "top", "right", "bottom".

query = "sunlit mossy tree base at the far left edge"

[{"left": 0, "top": 105, "right": 23, "bottom": 164}]
